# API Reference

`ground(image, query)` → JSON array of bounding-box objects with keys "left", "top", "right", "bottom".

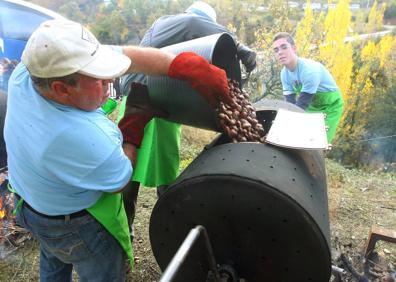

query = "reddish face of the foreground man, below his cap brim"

[{"left": 65, "top": 74, "right": 113, "bottom": 111}]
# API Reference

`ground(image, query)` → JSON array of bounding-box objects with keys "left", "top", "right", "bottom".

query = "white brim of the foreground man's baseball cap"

[{"left": 78, "top": 45, "right": 131, "bottom": 79}]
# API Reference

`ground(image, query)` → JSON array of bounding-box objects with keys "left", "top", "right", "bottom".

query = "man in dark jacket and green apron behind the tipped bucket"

[{"left": 119, "top": 1, "right": 256, "bottom": 236}]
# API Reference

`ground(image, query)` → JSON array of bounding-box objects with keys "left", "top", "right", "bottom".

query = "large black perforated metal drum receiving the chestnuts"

[{"left": 150, "top": 102, "right": 331, "bottom": 282}]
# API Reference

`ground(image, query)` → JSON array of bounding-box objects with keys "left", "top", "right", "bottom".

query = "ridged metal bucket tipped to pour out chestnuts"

[{"left": 147, "top": 33, "right": 241, "bottom": 131}]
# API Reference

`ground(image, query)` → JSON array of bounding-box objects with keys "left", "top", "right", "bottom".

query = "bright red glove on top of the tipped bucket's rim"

[{"left": 168, "top": 52, "right": 233, "bottom": 107}]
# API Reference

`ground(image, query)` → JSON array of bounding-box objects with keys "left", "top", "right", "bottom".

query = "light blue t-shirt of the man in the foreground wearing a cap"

[{"left": 4, "top": 63, "right": 132, "bottom": 215}]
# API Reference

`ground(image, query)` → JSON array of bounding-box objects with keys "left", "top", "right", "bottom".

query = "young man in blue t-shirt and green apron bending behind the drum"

[{"left": 272, "top": 32, "right": 344, "bottom": 143}]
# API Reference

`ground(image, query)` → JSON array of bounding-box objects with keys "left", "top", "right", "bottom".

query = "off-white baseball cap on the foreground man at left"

[{"left": 22, "top": 20, "right": 131, "bottom": 79}]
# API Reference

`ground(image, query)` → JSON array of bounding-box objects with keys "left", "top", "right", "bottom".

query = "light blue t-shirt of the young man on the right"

[{"left": 281, "top": 58, "right": 338, "bottom": 95}]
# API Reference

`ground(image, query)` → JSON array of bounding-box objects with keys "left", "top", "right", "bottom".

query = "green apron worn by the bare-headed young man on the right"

[{"left": 294, "top": 87, "right": 344, "bottom": 143}]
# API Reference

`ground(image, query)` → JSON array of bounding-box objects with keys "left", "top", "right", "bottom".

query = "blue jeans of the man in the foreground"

[{"left": 17, "top": 205, "right": 126, "bottom": 282}]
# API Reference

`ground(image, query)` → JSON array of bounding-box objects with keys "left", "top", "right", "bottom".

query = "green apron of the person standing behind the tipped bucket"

[{"left": 117, "top": 96, "right": 181, "bottom": 187}]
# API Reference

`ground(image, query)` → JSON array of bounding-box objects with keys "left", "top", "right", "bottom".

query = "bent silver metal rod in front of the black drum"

[{"left": 160, "top": 225, "right": 220, "bottom": 282}]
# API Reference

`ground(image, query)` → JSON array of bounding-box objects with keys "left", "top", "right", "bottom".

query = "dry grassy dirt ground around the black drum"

[{"left": 0, "top": 130, "right": 396, "bottom": 282}]
